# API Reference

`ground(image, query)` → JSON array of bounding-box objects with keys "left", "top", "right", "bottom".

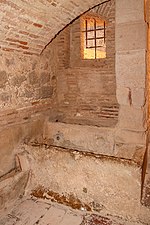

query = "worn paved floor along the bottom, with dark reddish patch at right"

[{"left": 0, "top": 198, "right": 148, "bottom": 225}]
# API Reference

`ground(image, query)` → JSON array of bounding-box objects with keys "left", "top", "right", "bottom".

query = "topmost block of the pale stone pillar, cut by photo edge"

[{"left": 116, "top": 0, "right": 144, "bottom": 24}]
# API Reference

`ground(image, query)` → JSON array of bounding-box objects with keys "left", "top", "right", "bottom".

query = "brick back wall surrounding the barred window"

[{"left": 48, "top": 1, "right": 119, "bottom": 127}]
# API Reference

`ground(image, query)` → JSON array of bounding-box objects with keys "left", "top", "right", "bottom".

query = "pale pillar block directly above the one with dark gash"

[{"left": 116, "top": 50, "right": 146, "bottom": 88}]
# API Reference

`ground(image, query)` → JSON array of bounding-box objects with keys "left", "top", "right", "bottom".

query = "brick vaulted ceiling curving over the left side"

[{"left": 0, "top": 0, "right": 109, "bottom": 55}]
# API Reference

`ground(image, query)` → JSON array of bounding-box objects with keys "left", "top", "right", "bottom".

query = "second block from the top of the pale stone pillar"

[{"left": 115, "top": 21, "right": 147, "bottom": 51}]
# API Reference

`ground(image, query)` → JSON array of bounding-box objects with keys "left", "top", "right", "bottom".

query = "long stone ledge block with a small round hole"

[{"left": 44, "top": 122, "right": 114, "bottom": 155}]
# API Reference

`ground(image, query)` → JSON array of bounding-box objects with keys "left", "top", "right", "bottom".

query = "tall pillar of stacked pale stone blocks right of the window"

[{"left": 116, "top": 0, "right": 147, "bottom": 155}]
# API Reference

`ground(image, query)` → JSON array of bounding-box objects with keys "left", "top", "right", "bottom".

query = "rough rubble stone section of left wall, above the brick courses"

[{"left": 0, "top": 51, "right": 54, "bottom": 110}]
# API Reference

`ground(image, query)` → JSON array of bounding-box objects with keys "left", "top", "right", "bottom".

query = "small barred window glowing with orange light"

[{"left": 81, "top": 17, "right": 106, "bottom": 59}]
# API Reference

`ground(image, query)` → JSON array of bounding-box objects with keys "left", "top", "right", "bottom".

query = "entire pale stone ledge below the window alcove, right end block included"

[{"left": 42, "top": 122, "right": 145, "bottom": 165}]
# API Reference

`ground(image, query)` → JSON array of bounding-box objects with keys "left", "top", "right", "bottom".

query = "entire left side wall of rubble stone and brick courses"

[{"left": 0, "top": 41, "right": 56, "bottom": 176}]
